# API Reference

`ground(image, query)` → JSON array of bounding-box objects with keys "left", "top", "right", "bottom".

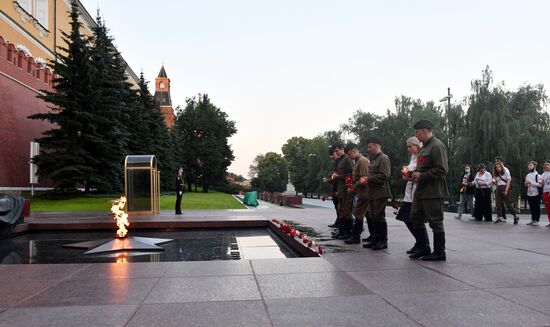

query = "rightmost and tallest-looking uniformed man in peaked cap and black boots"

[{"left": 409, "top": 120, "right": 449, "bottom": 261}]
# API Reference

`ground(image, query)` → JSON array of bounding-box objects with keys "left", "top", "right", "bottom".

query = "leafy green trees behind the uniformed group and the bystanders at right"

[{"left": 282, "top": 67, "right": 550, "bottom": 202}]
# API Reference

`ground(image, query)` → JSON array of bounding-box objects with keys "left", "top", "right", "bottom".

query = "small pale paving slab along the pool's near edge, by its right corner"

[{"left": 250, "top": 258, "right": 338, "bottom": 275}]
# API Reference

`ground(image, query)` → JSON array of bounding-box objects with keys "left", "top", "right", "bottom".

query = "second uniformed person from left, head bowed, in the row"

[{"left": 344, "top": 143, "right": 370, "bottom": 244}]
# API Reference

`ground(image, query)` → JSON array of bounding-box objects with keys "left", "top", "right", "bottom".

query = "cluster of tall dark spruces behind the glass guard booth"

[{"left": 29, "top": 2, "right": 180, "bottom": 193}]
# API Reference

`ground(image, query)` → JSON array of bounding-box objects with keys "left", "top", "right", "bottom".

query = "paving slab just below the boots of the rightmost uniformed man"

[{"left": 349, "top": 268, "right": 472, "bottom": 295}]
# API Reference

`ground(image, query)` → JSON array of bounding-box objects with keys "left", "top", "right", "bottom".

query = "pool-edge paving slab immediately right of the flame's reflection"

[{"left": 164, "top": 260, "right": 252, "bottom": 277}]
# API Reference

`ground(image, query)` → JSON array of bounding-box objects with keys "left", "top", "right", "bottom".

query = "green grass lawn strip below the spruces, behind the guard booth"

[{"left": 31, "top": 192, "right": 245, "bottom": 212}]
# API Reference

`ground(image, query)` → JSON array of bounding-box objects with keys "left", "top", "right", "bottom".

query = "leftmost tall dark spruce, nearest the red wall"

[{"left": 29, "top": 2, "right": 102, "bottom": 191}]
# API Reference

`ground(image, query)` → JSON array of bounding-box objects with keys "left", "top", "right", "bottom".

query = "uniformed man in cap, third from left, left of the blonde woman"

[{"left": 363, "top": 137, "right": 391, "bottom": 250}]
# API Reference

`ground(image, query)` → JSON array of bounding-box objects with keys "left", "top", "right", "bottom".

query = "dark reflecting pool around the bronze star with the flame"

[{"left": 0, "top": 228, "right": 299, "bottom": 264}]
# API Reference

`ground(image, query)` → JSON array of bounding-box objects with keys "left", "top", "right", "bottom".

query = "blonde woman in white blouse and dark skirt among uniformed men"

[{"left": 395, "top": 136, "right": 422, "bottom": 254}]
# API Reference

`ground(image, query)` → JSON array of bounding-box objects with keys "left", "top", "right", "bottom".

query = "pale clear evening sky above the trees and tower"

[{"left": 81, "top": 0, "right": 550, "bottom": 176}]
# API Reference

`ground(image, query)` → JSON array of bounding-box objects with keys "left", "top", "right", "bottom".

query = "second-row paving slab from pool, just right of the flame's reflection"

[{"left": 145, "top": 275, "right": 261, "bottom": 303}]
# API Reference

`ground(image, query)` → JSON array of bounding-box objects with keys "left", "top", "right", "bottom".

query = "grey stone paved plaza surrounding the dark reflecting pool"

[{"left": 0, "top": 200, "right": 550, "bottom": 327}]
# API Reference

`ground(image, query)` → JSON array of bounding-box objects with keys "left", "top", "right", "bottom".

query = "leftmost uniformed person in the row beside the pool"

[{"left": 332, "top": 143, "right": 353, "bottom": 240}]
